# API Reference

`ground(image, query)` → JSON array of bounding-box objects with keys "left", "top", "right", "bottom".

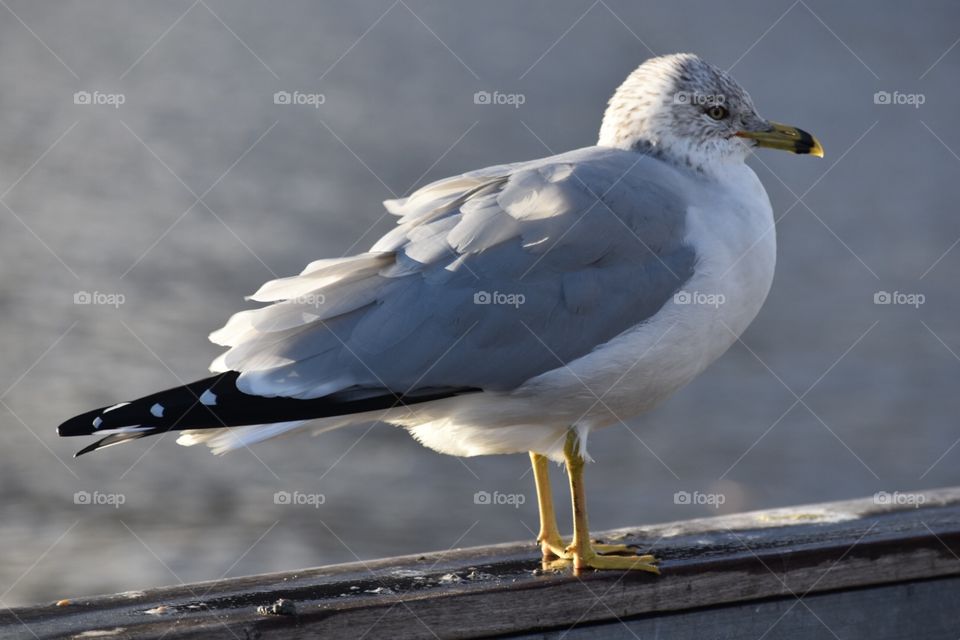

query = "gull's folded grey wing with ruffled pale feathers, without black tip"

[{"left": 211, "top": 147, "right": 695, "bottom": 398}]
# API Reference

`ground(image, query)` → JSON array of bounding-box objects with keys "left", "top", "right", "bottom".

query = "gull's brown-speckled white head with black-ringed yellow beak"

[{"left": 597, "top": 53, "right": 823, "bottom": 169}]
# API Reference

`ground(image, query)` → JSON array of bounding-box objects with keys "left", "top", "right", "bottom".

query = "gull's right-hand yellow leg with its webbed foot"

[{"left": 563, "top": 429, "right": 660, "bottom": 574}]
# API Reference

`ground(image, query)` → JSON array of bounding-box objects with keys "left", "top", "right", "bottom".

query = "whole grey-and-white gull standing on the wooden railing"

[{"left": 58, "top": 54, "right": 823, "bottom": 573}]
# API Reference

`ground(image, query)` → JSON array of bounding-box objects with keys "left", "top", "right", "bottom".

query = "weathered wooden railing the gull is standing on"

[{"left": 0, "top": 489, "right": 960, "bottom": 639}]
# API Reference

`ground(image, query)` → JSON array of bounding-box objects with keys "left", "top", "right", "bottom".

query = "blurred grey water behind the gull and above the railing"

[{"left": 0, "top": 0, "right": 960, "bottom": 605}]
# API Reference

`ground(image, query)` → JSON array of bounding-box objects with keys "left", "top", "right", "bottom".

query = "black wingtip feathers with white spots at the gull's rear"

[{"left": 57, "top": 371, "right": 465, "bottom": 456}]
